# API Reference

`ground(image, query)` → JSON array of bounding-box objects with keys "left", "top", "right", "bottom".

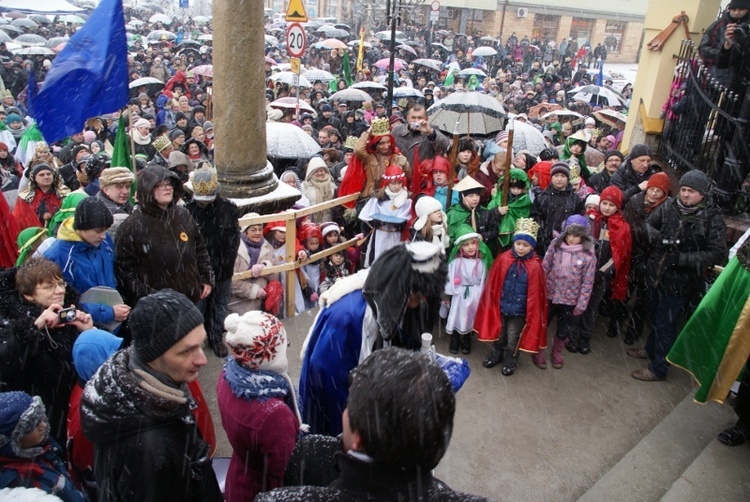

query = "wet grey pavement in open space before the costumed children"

[{"left": 201, "top": 313, "right": 750, "bottom": 501}]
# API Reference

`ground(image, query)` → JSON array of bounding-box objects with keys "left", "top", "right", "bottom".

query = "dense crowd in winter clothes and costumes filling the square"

[{"left": 0, "top": 3, "right": 750, "bottom": 501}]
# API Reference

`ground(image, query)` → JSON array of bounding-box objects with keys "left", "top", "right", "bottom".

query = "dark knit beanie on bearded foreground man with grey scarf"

[{"left": 130, "top": 288, "right": 203, "bottom": 363}]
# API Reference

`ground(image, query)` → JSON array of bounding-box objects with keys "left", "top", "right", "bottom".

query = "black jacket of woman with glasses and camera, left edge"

[{"left": 0, "top": 268, "right": 78, "bottom": 445}]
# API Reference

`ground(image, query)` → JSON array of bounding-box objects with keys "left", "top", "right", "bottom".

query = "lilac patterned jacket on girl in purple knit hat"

[{"left": 542, "top": 236, "right": 596, "bottom": 315}]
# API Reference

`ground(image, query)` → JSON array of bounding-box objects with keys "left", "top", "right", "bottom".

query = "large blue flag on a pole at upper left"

[{"left": 29, "top": 0, "right": 128, "bottom": 143}]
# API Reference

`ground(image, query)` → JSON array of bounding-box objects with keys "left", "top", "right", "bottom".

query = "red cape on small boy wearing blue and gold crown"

[{"left": 474, "top": 249, "right": 547, "bottom": 353}]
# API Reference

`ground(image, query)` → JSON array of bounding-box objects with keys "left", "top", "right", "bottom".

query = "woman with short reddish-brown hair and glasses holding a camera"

[{"left": 0, "top": 258, "right": 94, "bottom": 447}]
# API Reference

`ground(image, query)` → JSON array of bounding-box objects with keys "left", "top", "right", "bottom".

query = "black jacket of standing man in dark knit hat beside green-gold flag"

[{"left": 643, "top": 198, "right": 727, "bottom": 297}]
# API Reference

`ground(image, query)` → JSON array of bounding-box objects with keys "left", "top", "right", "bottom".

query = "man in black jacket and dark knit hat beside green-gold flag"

[{"left": 628, "top": 169, "right": 727, "bottom": 382}]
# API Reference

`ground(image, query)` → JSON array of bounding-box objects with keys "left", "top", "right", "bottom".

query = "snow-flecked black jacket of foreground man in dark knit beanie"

[{"left": 81, "top": 349, "right": 223, "bottom": 502}]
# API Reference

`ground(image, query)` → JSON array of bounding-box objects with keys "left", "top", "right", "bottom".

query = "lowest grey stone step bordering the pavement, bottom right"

[{"left": 578, "top": 392, "right": 747, "bottom": 502}]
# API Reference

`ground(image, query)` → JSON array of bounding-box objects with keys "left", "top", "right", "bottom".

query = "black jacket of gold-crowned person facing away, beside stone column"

[{"left": 185, "top": 195, "right": 240, "bottom": 283}]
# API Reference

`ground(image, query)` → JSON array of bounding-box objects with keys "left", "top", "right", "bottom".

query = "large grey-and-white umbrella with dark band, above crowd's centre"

[{"left": 427, "top": 91, "right": 506, "bottom": 136}]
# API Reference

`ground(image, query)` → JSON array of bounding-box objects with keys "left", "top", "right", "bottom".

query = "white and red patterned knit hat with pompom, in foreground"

[{"left": 224, "top": 310, "right": 288, "bottom": 375}]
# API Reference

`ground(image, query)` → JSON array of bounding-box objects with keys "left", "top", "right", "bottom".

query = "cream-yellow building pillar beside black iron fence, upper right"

[{"left": 620, "top": 0, "right": 721, "bottom": 151}]
